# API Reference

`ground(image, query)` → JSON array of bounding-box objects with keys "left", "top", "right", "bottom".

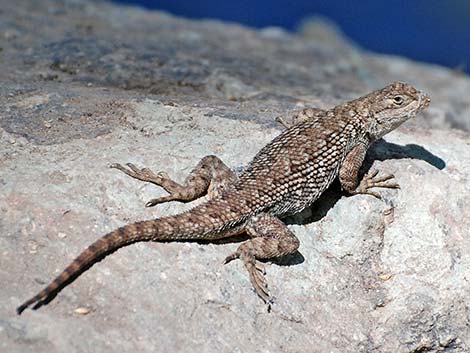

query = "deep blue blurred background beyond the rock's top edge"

[{"left": 116, "top": 0, "right": 470, "bottom": 72}]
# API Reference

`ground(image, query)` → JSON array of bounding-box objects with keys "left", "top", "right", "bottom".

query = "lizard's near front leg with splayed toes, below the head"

[{"left": 339, "top": 143, "right": 400, "bottom": 199}]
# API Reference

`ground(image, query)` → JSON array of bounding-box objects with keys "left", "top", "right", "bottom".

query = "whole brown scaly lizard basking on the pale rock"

[{"left": 17, "top": 82, "right": 430, "bottom": 314}]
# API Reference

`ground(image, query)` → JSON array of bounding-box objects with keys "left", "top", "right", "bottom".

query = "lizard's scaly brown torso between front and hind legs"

[{"left": 234, "top": 110, "right": 368, "bottom": 216}]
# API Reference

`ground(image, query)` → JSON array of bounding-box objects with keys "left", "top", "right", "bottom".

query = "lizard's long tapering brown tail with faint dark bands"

[{"left": 16, "top": 207, "right": 239, "bottom": 315}]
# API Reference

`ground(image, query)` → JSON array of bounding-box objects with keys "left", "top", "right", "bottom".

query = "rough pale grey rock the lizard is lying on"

[{"left": 0, "top": 0, "right": 470, "bottom": 353}]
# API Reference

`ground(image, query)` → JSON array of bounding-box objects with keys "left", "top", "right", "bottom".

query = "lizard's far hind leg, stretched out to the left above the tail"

[{"left": 110, "top": 156, "right": 237, "bottom": 207}]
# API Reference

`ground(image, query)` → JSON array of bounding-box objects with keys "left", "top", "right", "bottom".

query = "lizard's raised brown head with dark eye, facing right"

[{"left": 368, "top": 82, "right": 431, "bottom": 140}]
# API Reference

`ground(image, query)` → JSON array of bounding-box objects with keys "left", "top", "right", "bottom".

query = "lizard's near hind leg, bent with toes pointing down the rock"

[{"left": 225, "top": 214, "right": 300, "bottom": 307}]
